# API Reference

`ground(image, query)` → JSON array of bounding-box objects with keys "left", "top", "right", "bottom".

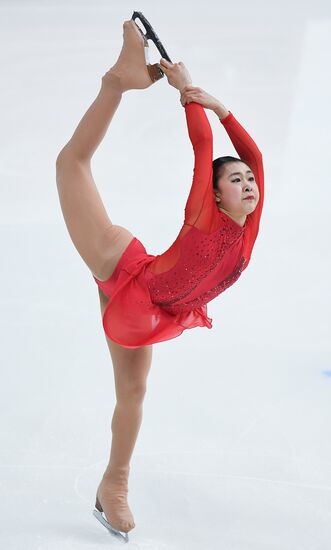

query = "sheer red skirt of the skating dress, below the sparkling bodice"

[{"left": 93, "top": 237, "right": 213, "bottom": 348}]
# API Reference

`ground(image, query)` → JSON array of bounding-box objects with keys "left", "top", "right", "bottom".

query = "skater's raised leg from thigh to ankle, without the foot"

[{"left": 56, "top": 83, "right": 133, "bottom": 280}]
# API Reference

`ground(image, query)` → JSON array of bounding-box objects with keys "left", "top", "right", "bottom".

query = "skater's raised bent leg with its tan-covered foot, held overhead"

[{"left": 56, "top": 21, "right": 152, "bottom": 280}]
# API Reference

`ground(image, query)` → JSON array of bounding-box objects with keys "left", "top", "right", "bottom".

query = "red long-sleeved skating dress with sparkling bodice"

[{"left": 93, "top": 102, "right": 264, "bottom": 348}]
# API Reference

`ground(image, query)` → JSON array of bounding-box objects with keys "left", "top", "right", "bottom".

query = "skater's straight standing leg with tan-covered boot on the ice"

[{"left": 97, "top": 290, "right": 153, "bottom": 532}]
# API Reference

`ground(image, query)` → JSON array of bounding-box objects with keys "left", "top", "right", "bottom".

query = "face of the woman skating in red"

[{"left": 214, "top": 161, "right": 260, "bottom": 219}]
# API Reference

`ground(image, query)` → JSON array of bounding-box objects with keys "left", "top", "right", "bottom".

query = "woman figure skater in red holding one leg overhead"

[{"left": 56, "top": 19, "right": 264, "bottom": 541}]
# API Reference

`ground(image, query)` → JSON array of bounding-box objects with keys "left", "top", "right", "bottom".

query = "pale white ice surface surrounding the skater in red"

[{"left": 0, "top": 0, "right": 331, "bottom": 550}]
